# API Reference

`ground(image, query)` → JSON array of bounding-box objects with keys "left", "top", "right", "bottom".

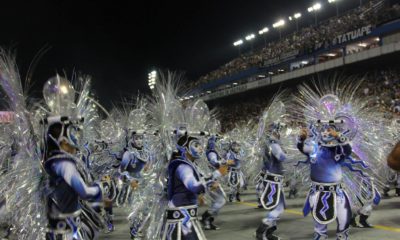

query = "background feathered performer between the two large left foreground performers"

[{"left": 105, "top": 101, "right": 153, "bottom": 239}]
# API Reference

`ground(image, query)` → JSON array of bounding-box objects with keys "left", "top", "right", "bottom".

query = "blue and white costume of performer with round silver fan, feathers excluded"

[{"left": 297, "top": 135, "right": 351, "bottom": 240}]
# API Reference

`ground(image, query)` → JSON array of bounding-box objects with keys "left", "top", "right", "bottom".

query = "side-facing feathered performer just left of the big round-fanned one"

[{"left": 252, "top": 92, "right": 289, "bottom": 239}]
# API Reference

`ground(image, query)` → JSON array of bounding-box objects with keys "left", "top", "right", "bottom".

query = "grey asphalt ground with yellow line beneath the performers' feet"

[{"left": 100, "top": 190, "right": 400, "bottom": 240}]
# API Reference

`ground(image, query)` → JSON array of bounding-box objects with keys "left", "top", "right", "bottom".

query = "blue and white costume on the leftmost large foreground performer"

[{"left": 44, "top": 151, "right": 102, "bottom": 239}]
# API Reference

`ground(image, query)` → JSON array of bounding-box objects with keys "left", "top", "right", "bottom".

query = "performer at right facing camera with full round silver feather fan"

[{"left": 291, "top": 77, "right": 386, "bottom": 239}]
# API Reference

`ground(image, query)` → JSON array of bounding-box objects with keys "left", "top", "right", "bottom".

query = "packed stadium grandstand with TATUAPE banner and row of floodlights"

[{"left": 181, "top": 0, "right": 400, "bottom": 130}]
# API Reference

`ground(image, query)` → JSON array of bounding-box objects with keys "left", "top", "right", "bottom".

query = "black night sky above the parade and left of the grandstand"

[{"left": 0, "top": 0, "right": 359, "bottom": 106}]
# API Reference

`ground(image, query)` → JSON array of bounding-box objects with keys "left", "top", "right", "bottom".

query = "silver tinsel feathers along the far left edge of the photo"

[{"left": 0, "top": 49, "right": 47, "bottom": 240}]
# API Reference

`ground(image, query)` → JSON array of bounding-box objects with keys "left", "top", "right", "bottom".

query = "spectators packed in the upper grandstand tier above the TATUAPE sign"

[{"left": 188, "top": 0, "right": 400, "bottom": 88}]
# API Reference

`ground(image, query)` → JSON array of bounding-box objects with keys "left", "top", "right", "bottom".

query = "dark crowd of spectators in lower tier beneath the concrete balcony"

[{"left": 218, "top": 70, "right": 400, "bottom": 132}]
